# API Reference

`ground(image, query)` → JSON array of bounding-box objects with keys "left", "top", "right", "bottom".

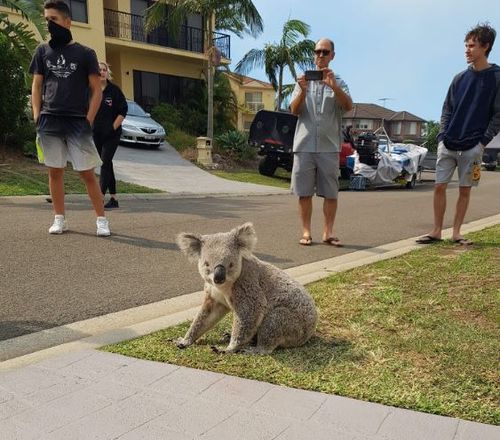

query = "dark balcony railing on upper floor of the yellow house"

[{"left": 104, "top": 9, "right": 231, "bottom": 58}]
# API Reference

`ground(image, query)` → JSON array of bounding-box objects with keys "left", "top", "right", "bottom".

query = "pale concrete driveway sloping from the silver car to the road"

[{"left": 113, "top": 143, "right": 290, "bottom": 195}]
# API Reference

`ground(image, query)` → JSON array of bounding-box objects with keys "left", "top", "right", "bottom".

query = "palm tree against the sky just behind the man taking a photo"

[{"left": 235, "top": 20, "right": 315, "bottom": 109}]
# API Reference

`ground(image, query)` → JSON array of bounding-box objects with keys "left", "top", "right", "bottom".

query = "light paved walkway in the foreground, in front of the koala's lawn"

[{"left": 0, "top": 350, "right": 500, "bottom": 440}]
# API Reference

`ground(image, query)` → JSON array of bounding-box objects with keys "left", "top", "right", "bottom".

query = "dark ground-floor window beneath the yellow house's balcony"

[{"left": 134, "top": 70, "right": 202, "bottom": 111}]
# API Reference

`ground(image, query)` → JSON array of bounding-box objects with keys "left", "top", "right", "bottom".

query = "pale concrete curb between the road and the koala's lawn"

[{"left": 0, "top": 214, "right": 500, "bottom": 371}]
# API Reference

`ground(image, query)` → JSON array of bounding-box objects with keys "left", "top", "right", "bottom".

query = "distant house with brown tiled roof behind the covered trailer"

[{"left": 342, "top": 103, "right": 427, "bottom": 143}]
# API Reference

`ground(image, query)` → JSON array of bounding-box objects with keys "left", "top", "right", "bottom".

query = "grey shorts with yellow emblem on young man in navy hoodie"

[{"left": 436, "top": 142, "right": 483, "bottom": 187}]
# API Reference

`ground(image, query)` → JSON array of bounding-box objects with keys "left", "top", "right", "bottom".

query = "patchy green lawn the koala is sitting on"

[{"left": 103, "top": 225, "right": 500, "bottom": 425}]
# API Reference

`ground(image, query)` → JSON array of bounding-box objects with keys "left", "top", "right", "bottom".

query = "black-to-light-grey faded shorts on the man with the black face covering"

[{"left": 37, "top": 115, "right": 102, "bottom": 171}]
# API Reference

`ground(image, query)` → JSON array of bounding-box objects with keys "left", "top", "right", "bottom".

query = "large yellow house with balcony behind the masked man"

[{"left": 0, "top": 0, "right": 230, "bottom": 109}]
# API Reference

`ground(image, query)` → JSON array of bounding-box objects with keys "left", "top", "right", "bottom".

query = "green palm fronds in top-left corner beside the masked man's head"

[{"left": 0, "top": 0, "right": 46, "bottom": 65}]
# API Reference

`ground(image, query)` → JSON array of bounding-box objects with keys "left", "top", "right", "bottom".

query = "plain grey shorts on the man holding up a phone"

[{"left": 292, "top": 153, "right": 339, "bottom": 199}]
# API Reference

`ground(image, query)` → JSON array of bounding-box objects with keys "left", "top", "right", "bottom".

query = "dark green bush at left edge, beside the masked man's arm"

[{"left": 0, "top": 39, "right": 29, "bottom": 148}]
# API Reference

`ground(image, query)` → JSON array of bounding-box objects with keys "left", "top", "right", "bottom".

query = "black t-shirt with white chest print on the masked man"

[{"left": 29, "top": 43, "right": 99, "bottom": 117}]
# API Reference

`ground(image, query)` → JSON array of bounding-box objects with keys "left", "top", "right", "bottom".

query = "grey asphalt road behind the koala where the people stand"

[{"left": 0, "top": 172, "right": 500, "bottom": 340}]
